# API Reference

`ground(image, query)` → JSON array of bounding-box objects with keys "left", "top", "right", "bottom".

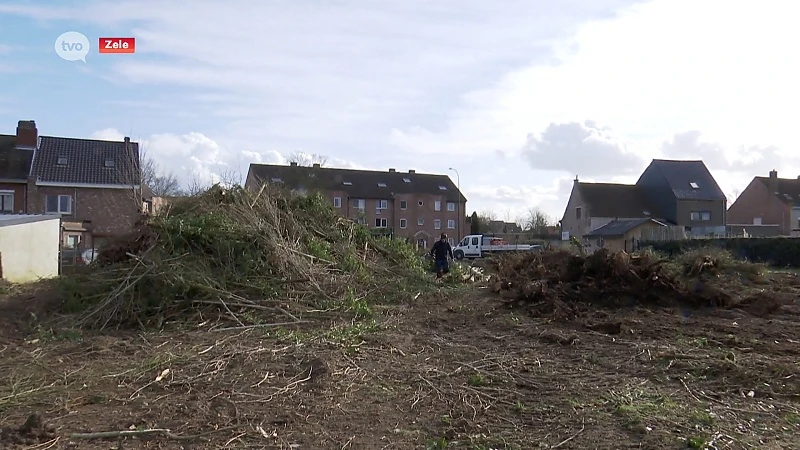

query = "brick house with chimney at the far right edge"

[{"left": 727, "top": 170, "right": 800, "bottom": 236}]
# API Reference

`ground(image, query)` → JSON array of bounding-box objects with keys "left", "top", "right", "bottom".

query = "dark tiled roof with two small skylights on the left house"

[{"left": 31, "top": 136, "right": 141, "bottom": 185}]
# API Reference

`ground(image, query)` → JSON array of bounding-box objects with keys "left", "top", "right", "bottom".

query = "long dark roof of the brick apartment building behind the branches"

[{"left": 248, "top": 164, "right": 467, "bottom": 202}]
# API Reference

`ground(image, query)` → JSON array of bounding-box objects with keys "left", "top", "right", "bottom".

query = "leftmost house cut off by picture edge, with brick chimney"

[{"left": 0, "top": 120, "right": 36, "bottom": 214}]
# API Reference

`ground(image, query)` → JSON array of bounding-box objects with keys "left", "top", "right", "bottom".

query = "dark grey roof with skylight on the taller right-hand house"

[{"left": 637, "top": 159, "right": 727, "bottom": 200}]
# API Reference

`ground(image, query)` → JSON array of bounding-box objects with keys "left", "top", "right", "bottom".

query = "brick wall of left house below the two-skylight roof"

[{"left": 28, "top": 183, "right": 141, "bottom": 236}]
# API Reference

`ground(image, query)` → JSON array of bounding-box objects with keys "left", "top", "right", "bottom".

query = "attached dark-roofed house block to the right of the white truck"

[{"left": 561, "top": 159, "right": 727, "bottom": 245}]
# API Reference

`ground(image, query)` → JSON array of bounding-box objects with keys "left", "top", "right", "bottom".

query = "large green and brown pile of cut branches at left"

[{"left": 64, "top": 185, "right": 424, "bottom": 328}]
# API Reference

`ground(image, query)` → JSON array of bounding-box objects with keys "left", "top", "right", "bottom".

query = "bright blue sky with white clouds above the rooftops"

[{"left": 0, "top": 0, "right": 800, "bottom": 225}]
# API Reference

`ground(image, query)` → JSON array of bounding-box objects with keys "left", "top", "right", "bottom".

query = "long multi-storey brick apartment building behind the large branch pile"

[{"left": 245, "top": 163, "right": 469, "bottom": 248}]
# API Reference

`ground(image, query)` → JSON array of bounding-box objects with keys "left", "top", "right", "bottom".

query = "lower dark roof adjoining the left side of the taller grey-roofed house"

[{"left": 578, "top": 182, "right": 655, "bottom": 219}]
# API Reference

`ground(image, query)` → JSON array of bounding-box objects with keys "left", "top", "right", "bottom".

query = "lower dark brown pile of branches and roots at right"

[{"left": 490, "top": 249, "right": 730, "bottom": 318}]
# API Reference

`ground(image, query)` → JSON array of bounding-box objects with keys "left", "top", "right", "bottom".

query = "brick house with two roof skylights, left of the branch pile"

[{"left": 0, "top": 120, "right": 143, "bottom": 248}]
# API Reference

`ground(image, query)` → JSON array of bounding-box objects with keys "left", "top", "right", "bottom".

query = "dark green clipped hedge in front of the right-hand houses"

[{"left": 640, "top": 237, "right": 800, "bottom": 267}]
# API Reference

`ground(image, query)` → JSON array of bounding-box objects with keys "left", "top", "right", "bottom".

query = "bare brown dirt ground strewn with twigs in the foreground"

[{"left": 0, "top": 274, "right": 800, "bottom": 450}]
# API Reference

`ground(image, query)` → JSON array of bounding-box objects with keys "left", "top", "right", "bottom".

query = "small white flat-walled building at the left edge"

[{"left": 0, "top": 214, "right": 61, "bottom": 283}]
